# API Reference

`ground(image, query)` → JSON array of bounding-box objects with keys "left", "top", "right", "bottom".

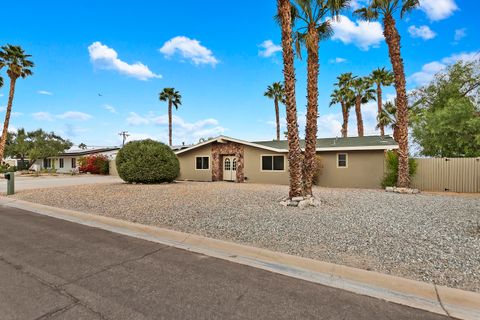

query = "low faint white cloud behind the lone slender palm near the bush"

[{"left": 127, "top": 112, "right": 226, "bottom": 143}]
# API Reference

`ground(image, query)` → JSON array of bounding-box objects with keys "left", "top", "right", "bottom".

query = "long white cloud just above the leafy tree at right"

[{"left": 408, "top": 52, "right": 480, "bottom": 86}]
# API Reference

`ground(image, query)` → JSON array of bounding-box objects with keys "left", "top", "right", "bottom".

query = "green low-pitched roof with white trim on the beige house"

[{"left": 176, "top": 136, "right": 398, "bottom": 154}]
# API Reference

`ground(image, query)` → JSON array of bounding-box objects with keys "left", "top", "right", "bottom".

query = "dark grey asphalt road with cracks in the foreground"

[{"left": 0, "top": 206, "right": 446, "bottom": 320}]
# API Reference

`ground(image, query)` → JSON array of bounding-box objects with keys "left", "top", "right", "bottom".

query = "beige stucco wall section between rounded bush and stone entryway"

[{"left": 177, "top": 144, "right": 212, "bottom": 181}]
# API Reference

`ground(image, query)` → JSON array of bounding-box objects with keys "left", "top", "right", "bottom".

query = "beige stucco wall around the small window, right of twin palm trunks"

[{"left": 318, "top": 150, "right": 385, "bottom": 189}]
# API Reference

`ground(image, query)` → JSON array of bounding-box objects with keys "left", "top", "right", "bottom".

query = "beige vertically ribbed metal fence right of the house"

[{"left": 412, "top": 158, "right": 480, "bottom": 193}]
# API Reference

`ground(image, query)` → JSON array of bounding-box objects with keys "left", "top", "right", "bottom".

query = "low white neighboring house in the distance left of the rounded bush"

[{"left": 32, "top": 147, "right": 120, "bottom": 173}]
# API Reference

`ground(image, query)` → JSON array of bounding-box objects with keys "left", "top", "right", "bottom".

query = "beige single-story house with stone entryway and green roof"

[{"left": 175, "top": 136, "right": 398, "bottom": 188}]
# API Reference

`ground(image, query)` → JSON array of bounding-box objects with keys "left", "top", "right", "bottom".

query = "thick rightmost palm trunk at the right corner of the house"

[{"left": 383, "top": 16, "right": 410, "bottom": 188}]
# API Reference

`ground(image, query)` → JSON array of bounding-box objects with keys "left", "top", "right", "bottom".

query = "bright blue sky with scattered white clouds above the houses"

[{"left": 0, "top": 0, "right": 480, "bottom": 146}]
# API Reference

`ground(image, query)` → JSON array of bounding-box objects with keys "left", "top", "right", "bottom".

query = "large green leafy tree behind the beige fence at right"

[{"left": 411, "top": 60, "right": 480, "bottom": 157}]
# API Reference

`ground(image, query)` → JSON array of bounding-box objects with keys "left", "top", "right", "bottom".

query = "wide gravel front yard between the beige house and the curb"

[{"left": 11, "top": 182, "right": 480, "bottom": 292}]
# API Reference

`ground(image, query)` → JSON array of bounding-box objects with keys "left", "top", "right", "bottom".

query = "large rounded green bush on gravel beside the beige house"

[{"left": 116, "top": 139, "right": 180, "bottom": 183}]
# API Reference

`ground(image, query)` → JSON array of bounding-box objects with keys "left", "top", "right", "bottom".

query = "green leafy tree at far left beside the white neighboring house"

[{"left": 5, "top": 128, "right": 73, "bottom": 168}]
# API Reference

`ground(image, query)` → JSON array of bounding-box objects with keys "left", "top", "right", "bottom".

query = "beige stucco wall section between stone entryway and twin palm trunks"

[{"left": 244, "top": 146, "right": 289, "bottom": 184}]
